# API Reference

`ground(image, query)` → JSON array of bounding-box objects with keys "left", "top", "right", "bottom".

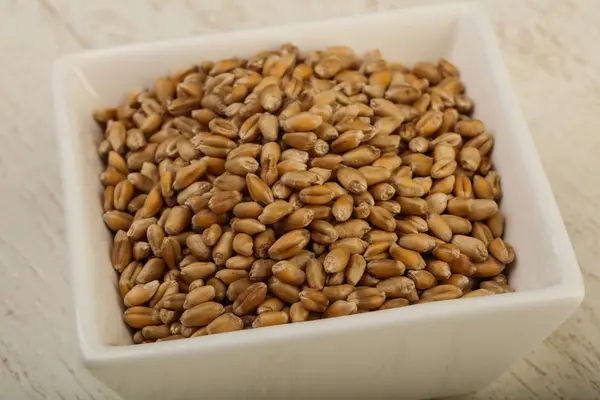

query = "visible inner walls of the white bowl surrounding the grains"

[{"left": 59, "top": 4, "right": 558, "bottom": 345}]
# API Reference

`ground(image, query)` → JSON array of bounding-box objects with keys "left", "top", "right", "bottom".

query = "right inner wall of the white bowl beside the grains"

[{"left": 449, "top": 18, "right": 560, "bottom": 291}]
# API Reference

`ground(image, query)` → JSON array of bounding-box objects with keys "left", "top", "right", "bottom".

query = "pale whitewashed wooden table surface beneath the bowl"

[{"left": 0, "top": 0, "right": 600, "bottom": 399}]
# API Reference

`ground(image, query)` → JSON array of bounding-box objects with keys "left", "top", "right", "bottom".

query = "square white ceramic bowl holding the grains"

[{"left": 53, "top": 4, "right": 583, "bottom": 399}]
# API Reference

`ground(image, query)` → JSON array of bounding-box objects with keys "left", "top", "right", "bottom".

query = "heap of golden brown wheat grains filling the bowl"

[{"left": 93, "top": 44, "right": 515, "bottom": 343}]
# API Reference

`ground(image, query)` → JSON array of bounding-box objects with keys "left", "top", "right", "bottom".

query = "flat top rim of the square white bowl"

[{"left": 52, "top": 3, "right": 584, "bottom": 366}]
